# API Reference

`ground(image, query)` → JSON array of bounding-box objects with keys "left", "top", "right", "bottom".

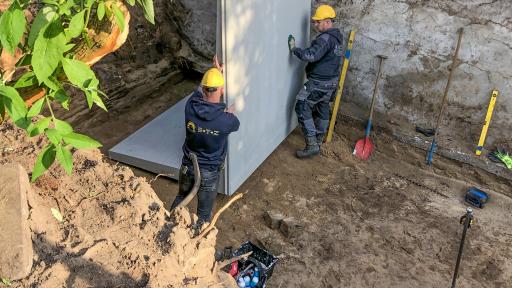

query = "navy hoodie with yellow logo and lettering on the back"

[{"left": 183, "top": 88, "right": 240, "bottom": 171}]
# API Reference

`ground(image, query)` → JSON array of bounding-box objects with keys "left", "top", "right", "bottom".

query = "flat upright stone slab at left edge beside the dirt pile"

[{"left": 0, "top": 164, "right": 33, "bottom": 280}]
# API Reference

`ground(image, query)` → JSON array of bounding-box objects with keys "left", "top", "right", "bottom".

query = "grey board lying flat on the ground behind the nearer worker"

[{"left": 108, "top": 97, "right": 188, "bottom": 179}]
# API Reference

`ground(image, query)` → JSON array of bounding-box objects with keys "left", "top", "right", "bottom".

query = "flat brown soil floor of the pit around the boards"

[{"left": 61, "top": 75, "right": 512, "bottom": 287}]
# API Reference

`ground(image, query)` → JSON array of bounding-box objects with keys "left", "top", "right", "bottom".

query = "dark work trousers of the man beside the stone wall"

[{"left": 295, "top": 79, "right": 338, "bottom": 137}]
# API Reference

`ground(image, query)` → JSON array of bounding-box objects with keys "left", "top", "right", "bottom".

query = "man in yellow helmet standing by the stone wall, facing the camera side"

[{"left": 288, "top": 5, "right": 343, "bottom": 158}]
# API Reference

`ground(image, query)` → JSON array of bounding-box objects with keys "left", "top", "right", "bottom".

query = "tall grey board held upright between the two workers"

[{"left": 221, "top": 0, "right": 311, "bottom": 195}]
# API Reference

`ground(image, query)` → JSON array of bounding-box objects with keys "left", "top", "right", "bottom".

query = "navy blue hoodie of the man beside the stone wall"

[{"left": 292, "top": 28, "right": 343, "bottom": 81}]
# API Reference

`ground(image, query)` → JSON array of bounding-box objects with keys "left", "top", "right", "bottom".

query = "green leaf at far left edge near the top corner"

[{"left": 0, "top": 8, "right": 27, "bottom": 55}]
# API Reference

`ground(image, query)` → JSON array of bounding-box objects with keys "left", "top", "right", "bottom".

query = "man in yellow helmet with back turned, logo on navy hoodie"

[{"left": 171, "top": 58, "right": 240, "bottom": 228}]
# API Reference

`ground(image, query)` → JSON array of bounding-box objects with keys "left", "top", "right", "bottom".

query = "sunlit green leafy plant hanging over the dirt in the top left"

[{"left": 0, "top": 0, "right": 154, "bottom": 181}]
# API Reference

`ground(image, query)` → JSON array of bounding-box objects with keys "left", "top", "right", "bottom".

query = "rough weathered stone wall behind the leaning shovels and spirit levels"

[{"left": 320, "top": 0, "right": 512, "bottom": 152}]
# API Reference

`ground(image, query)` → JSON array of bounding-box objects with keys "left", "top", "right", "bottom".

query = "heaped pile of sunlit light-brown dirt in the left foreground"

[{"left": 0, "top": 118, "right": 236, "bottom": 287}]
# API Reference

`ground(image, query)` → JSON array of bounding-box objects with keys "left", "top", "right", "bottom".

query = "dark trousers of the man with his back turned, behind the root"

[{"left": 171, "top": 165, "right": 221, "bottom": 222}]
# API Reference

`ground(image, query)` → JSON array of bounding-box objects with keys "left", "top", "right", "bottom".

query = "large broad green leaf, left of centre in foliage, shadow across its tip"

[{"left": 32, "top": 20, "right": 66, "bottom": 83}]
